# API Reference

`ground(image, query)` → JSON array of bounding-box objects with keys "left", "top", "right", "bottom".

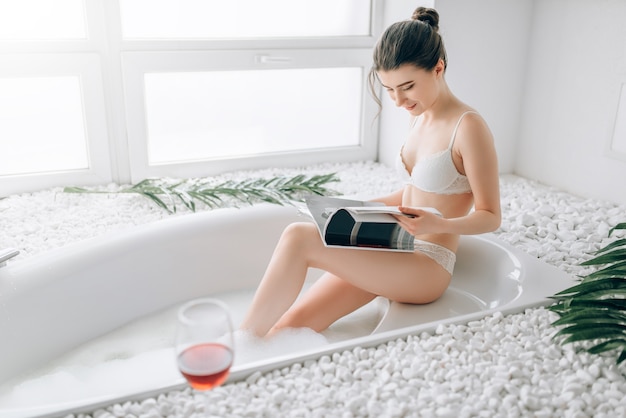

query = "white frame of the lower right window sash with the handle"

[{"left": 122, "top": 49, "right": 377, "bottom": 182}]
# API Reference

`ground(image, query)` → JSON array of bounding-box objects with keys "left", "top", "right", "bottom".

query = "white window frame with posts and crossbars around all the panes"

[{"left": 0, "top": 0, "right": 383, "bottom": 196}]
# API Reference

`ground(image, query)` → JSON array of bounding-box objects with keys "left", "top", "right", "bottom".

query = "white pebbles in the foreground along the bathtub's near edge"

[{"left": 72, "top": 308, "right": 626, "bottom": 418}]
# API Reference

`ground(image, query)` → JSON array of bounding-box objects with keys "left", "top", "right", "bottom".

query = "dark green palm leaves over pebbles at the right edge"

[{"left": 549, "top": 223, "right": 626, "bottom": 364}]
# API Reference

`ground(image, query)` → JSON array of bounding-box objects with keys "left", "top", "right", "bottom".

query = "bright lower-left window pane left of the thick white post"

[{"left": 0, "top": 76, "right": 89, "bottom": 175}]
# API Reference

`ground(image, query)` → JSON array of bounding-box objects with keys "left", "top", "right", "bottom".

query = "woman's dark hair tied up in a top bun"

[{"left": 369, "top": 7, "right": 448, "bottom": 106}]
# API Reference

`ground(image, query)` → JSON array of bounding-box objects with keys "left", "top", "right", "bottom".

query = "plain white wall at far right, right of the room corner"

[{"left": 515, "top": 0, "right": 626, "bottom": 206}]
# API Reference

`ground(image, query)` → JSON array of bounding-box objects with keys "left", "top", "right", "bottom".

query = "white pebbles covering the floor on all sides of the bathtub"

[{"left": 0, "top": 163, "right": 626, "bottom": 418}]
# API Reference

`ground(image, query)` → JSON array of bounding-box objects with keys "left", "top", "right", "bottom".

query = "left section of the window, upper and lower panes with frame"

[{"left": 0, "top": 0, "right": 112, "bottom": 196}]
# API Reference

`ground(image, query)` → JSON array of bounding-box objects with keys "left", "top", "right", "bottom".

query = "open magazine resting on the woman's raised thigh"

[{"left": 306, "top": 196, "right": 441, "bottom": 252}]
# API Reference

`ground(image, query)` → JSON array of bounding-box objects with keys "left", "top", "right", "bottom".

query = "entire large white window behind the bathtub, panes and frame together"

[{"left": 0, "top": 0, "right": 382, "bottom": 195}]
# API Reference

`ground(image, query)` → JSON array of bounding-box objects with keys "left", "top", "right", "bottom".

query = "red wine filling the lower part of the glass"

[{"left": 178, "top": 343, "right": 233, "bottom": 390}]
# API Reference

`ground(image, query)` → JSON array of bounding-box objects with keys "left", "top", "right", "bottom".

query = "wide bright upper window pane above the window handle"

[{"left": 120, "top": 0, "right": 371, "bottom": 40}]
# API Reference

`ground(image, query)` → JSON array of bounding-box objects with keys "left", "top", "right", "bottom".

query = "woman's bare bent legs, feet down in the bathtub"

[{"left": 242, "top": 223, "right": 450, "bottom": 336}]
